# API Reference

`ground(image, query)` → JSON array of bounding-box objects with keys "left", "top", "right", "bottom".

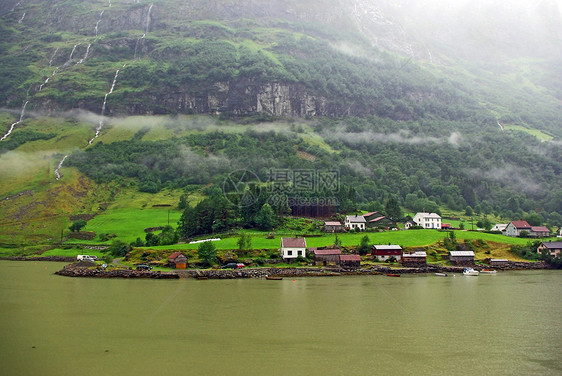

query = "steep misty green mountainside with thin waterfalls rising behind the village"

[{"left": 0, "top": 0, "right": 562, "bottom": 253}]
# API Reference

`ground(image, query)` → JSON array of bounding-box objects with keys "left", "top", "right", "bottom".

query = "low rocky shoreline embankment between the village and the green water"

[{"left": 50, "top": 262, "right": 551, "bottom": 279}]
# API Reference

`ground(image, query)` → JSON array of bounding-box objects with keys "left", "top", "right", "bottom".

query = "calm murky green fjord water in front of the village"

[{"left": 0, "top": 261, "right": 562, "bottom": 375}]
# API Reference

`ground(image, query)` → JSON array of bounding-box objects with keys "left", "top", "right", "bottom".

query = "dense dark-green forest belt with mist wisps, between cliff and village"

[{"left": 68, "top": 117, "right": 562, "bottom": 223}]
